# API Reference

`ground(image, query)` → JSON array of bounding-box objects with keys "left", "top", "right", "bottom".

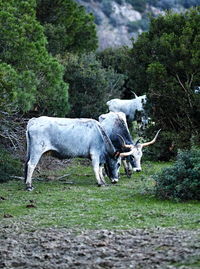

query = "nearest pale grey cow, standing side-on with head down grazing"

[{"left": 25, "top": 116, "right": 133, "bottom": 190}]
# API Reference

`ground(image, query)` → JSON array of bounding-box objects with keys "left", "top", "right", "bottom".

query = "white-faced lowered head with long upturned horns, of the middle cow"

[{"left": 120, "top": 129, "right": 161, "bottom": 172}]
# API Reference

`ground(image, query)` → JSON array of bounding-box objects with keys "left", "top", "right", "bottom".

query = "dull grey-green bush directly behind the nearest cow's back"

[{"left": 63, "top": 53, "right": 124, "bottom": 119}]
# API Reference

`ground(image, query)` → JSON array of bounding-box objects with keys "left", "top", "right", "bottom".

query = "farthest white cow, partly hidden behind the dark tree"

[{"left": 106, "top": 94, "right": 146, "bottom": 122}]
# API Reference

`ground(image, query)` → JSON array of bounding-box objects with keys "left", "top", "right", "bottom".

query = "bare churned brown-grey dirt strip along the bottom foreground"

[{"left": 0, "top": 226, "right": 200, "bottom": 269}]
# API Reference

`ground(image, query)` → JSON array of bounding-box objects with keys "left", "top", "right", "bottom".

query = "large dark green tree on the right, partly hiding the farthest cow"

[{"left": 129, "top": 9, "right": 200, "bottom": 155}]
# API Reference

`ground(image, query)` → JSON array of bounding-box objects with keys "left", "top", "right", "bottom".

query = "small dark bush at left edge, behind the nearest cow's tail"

[{"left": 0, "top": 147, "right": 22, "bottom": 183}]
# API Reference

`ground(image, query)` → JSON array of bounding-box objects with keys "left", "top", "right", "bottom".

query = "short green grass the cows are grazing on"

[{"left": 0, "top": 160, "right": 200, "bottom": 229}]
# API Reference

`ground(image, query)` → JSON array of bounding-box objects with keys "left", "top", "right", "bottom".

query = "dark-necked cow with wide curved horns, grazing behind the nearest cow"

[{"left": 99, "top": 112, "right": 160, "bottom": 177}]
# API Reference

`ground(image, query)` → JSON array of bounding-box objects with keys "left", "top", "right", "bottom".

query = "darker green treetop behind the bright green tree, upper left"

[{"left": 36, "top": 0, "right": 97, "bottom": 55}]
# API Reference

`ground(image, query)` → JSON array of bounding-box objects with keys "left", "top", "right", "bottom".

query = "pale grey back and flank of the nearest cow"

[{"left": 27, "top": 116, "right": 102, "bottom": 157}]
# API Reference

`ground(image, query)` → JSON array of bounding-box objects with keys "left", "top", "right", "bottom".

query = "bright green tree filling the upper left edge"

[{"left": 0, "top": 0, "right": 68, "bottom": 115}]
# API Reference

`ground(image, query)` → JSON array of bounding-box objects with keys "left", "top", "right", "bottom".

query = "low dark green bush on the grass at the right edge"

[{"left": 155, "top": 148, "right": 200, "bottom": 201}]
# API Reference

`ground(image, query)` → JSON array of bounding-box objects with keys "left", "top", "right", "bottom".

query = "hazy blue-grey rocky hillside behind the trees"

[{"left": 76, "top": 0, "right": 200, "bottom": 50}]
